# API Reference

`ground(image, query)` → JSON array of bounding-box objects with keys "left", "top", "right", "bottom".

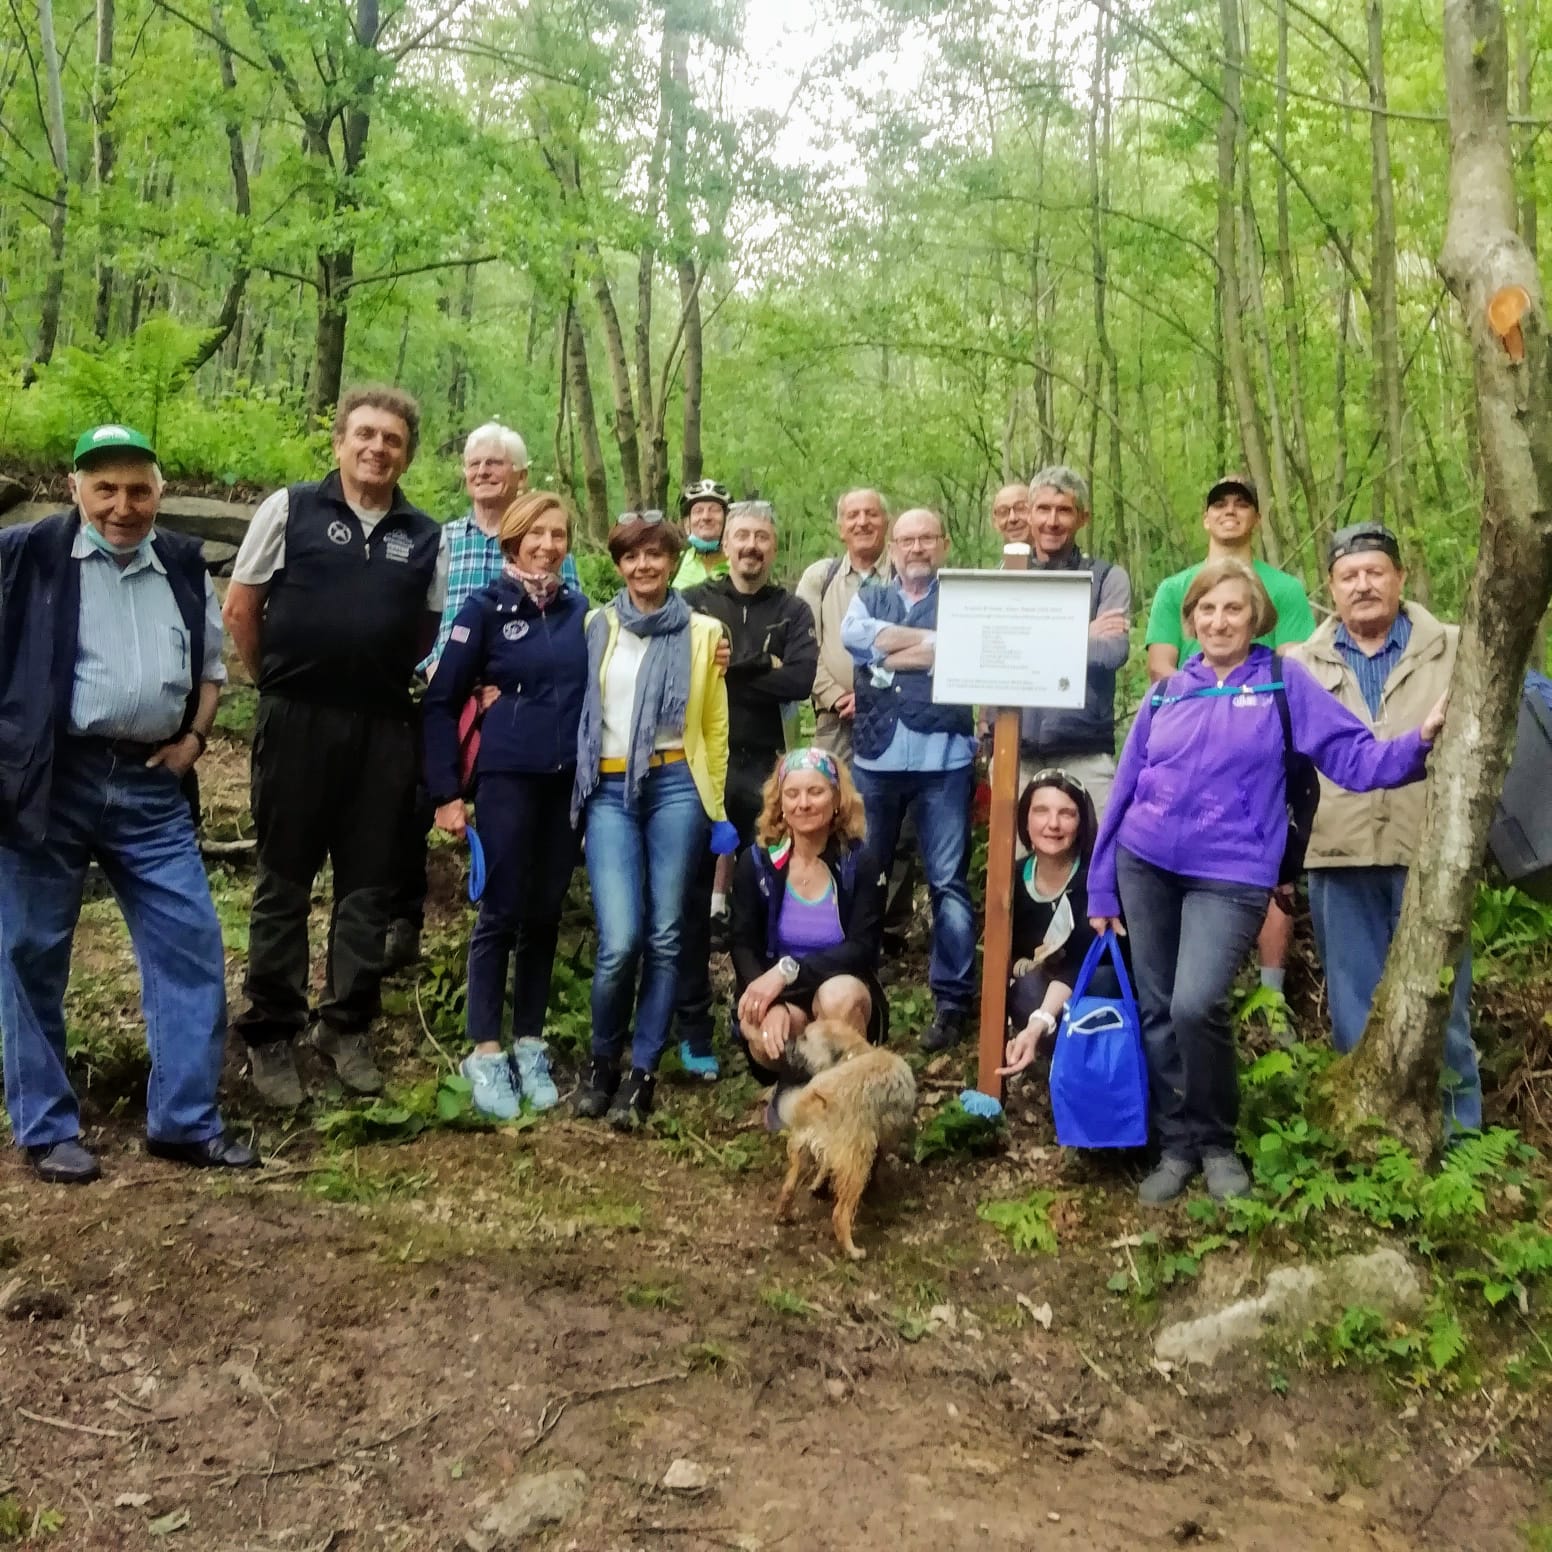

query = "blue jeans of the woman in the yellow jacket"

[{"left": 587, "top": 760, "right": 711, "bottom": 1072}]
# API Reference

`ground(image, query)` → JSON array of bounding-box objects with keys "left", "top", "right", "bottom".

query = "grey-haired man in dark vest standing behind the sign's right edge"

[{"left": 1018, "top": 464, "right": 1131, "bottom": 816}]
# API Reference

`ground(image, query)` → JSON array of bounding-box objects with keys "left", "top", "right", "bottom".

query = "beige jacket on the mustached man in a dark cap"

[{"left": 1287, "top": 602, "right": 1460, "bottom": 868}]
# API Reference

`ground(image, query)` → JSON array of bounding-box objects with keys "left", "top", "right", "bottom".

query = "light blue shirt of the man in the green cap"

[{"left": 70, "top": 534, "right": 227, "bottom": 743}]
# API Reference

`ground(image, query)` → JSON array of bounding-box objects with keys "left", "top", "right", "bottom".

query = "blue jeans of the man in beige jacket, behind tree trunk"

[{"left": 1310, "top": 868, "right": 1482, "bottom": 1131}]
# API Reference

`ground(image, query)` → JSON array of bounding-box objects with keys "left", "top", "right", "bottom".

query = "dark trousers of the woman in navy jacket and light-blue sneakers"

[{"left": 466, "top": 770, "right": 579, "bottom": 1044}]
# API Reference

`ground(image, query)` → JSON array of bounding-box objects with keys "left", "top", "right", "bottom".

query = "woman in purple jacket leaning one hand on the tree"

[{"left": 1088, "top": 559, "right": 1445, "bottom": 1206}]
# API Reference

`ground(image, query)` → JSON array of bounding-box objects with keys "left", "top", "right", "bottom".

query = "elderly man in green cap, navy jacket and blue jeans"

[{"left": 0, "top": 425, "right": 258, "bottom": 1184}]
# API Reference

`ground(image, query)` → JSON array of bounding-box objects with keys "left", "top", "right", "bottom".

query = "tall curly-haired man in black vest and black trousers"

[{"left": 225, "top": 388, "right": 447, "bottom": 1108}]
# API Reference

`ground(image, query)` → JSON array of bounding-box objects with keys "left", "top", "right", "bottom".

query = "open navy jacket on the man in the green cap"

[{"left": 0, "top": 508, "right": 205, "bottom": 844}]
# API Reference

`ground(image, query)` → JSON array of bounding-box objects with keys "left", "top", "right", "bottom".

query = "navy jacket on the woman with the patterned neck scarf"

[{"left": 421, "top": 576, "right": 588, "bottom": 804}]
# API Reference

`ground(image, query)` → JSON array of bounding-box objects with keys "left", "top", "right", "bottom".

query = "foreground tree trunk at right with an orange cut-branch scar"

[{"left": 1325, "top": 0, "right": 1552, "bottom": 1153}]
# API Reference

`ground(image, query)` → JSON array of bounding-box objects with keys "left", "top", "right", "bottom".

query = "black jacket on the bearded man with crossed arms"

[{"left": 684, "top": 577, "right": 819, "bottom": 756}]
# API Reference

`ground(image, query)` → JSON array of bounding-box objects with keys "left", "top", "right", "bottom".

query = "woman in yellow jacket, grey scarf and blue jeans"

[{"left": 571, "top": 512, "right": 737, "bottom": 1131}]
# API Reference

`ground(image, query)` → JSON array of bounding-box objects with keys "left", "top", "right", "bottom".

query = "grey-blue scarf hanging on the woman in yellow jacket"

[{"left": 571, "top": 593, "right": 691, "bottom": 824}]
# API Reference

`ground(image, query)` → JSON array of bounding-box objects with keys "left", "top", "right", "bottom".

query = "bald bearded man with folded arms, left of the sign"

[{"left": 841, "top": 508, "right": 976, "bottom": 1051}]
